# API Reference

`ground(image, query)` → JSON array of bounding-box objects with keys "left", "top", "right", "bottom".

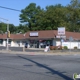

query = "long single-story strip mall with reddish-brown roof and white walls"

[{"left": 0, "top": 30, "right": 80, "bottom": 49}]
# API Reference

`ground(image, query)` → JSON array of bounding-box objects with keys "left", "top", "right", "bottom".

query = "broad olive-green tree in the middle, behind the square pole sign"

[{"left": 40, "top": 4, "right": 66, "bottom": 30}]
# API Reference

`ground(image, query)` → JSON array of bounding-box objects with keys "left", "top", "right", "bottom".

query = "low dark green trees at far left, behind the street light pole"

[{"left": 0, "top": 23, "right": 29, "bottom": 34}]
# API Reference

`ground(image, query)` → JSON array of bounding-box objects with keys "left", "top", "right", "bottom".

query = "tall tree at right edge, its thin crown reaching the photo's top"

[{"left": 67, "top": 0, "right": 80, "bottom": 32}]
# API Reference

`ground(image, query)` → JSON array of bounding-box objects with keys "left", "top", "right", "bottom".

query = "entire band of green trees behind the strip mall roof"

[{"left": 0, "top": 0, "right": 80, "bottom": 33}]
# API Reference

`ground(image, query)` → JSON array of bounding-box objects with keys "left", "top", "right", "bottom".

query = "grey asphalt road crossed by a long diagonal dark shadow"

[{"left": 0, "top": 53, "right": 80, "bottom": 80}]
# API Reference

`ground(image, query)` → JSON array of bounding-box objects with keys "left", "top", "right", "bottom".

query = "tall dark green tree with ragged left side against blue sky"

[{"left": 20, "top": 3, "right": 40, "bottom": 30}]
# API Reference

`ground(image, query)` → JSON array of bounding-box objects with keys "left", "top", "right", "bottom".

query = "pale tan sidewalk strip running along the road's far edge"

[{"left": 0, "top": 50, "right": 80, "bottom": 55}]
